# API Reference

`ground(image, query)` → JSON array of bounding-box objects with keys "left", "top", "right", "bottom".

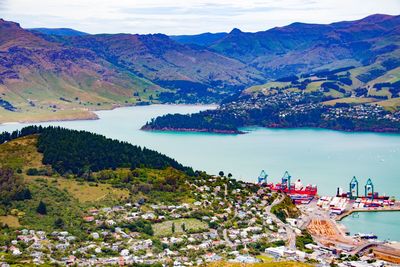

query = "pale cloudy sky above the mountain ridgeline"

[{"left": 0, "top": 0, "right": 400, "bottom": 35}]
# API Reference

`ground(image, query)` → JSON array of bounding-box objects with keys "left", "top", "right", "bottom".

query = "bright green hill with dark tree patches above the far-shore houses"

[{"left": 243, "top": 61, "right": 400, "bottom": 111}]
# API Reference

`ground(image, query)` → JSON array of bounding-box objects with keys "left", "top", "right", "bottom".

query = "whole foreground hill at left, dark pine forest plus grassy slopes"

[{"left": 0, "top": 127, "right": 197, "bottom": 236}]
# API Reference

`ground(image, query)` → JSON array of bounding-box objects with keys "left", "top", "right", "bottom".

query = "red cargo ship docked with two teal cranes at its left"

[{"left": 258, "top": 171, "right": 318, "bottom": 197}]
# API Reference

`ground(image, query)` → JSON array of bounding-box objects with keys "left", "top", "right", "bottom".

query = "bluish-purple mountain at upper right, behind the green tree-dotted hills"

[{"left": 209, "top": 14, "right": 400, "bottom": 78}]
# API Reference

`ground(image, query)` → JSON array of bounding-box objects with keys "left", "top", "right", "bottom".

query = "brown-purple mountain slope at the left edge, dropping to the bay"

[{"left": 0, "top": 20, "right": 160, "bottom": 118}]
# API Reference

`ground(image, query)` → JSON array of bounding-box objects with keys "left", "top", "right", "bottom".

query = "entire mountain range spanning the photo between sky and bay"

[{"left": 0, "top": 14, "right": 400, "bottom": 121}]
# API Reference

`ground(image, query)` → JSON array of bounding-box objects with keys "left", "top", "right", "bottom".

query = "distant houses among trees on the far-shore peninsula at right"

[{"left": 220, "top": 89, "right": 400, "bottom": 131}]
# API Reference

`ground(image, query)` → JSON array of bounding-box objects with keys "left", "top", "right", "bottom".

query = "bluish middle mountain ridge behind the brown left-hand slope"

[{"left": 39, "top": 31, "right": 265, "bottom": 101}]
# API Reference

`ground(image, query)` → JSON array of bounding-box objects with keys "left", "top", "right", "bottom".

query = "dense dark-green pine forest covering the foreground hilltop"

[{"left": 38, "top": 128, "right": 189, "bottom": 175}]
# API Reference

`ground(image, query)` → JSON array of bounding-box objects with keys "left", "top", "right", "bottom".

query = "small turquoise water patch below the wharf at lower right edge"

[{"left": 341, "top": 211, "right": 400, "bottom": 241}]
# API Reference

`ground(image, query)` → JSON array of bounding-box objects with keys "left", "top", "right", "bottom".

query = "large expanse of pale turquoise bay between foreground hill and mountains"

[{"left": 0, "top": 105, "right": 400, "bottom": 198}]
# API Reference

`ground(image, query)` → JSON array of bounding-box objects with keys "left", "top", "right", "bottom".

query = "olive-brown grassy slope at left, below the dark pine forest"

[{"left": 0, "top": 135, "right": 129, "bottom": 234}]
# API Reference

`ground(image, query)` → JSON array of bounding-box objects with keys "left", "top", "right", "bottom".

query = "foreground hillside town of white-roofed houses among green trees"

[{"left": 0, "top": 174, "right": 398, "bottom": 267}]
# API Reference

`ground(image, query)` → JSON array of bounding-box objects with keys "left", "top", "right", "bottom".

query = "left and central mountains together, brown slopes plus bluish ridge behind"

[{"left": 0, "top": 20, "right": 263, "bottom": 121}]
